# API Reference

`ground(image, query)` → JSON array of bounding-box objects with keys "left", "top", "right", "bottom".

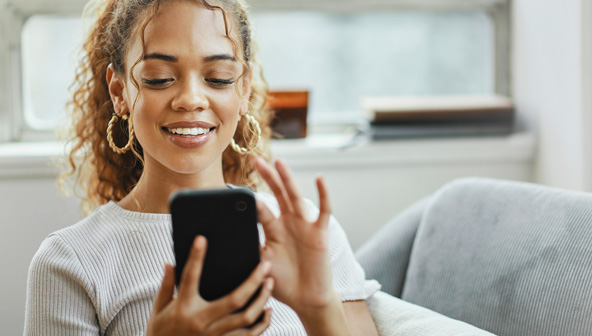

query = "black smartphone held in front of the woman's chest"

[{"left": 169, "top": 188, "right": 260, "bottom": 311}]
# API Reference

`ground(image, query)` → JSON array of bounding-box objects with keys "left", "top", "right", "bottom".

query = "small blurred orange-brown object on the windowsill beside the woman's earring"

[{"left": 267, "top": 91, "right": 308, "bottom": 139}]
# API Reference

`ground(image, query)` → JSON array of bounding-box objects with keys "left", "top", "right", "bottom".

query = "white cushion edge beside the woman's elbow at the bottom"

[{"left": 366, "top": 292, "right": 493, "bottom": 336}]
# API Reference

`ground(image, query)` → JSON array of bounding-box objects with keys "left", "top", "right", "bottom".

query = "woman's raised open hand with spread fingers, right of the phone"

[{"left": 255, "top": 159, "right": 341, "bottom": 315}]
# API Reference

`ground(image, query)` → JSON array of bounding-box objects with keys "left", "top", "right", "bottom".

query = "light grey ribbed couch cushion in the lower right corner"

[{"left": 402, "top": 178, "right": 592, "bottom": 335}]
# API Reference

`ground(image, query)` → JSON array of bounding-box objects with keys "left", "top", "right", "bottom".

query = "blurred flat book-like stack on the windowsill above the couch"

[{"left": 362, "top": 95, "right": 514, "bottom": 140}]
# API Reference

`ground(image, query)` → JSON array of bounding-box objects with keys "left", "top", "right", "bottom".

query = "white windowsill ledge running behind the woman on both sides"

[{"left": 0, "top": 132, "right": 536, "bottom": 179}]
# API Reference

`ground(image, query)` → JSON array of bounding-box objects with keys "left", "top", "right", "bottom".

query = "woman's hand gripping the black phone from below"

[{"left": 147, "top": 236, "right": 274, "bottom": 336}]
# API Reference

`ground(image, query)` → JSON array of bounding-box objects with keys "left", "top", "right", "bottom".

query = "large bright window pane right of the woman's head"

[{"left": 253, "top": 12, "right": 495, "bottom": 123}]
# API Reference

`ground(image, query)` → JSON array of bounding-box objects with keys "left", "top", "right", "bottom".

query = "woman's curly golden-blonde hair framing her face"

[{"left": 59, "top": 0, "right": 271, "bottom": 214}]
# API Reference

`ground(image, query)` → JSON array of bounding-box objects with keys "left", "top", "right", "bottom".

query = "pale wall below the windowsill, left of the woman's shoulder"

[{"left": 0, "top": 177, "right": 80, "bottom": 335}]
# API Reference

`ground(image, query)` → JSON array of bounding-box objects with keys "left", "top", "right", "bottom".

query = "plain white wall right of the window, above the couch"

[{"left": 512, "top": 0, "right": 592, "bottom": 191}]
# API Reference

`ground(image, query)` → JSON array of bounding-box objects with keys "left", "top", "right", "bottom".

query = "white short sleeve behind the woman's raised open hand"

[{"left": 305, "top": 199, "right": 380, "bottom": 301}]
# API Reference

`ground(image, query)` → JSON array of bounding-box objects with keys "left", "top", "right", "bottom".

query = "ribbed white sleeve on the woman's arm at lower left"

[{"left": 24, "top": 235, "right": 99, "bottom": 335}]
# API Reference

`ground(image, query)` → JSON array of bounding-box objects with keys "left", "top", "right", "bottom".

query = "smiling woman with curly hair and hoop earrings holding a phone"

[{"left": 25, "top": 0, "right": 379, "bottom": 335}]
